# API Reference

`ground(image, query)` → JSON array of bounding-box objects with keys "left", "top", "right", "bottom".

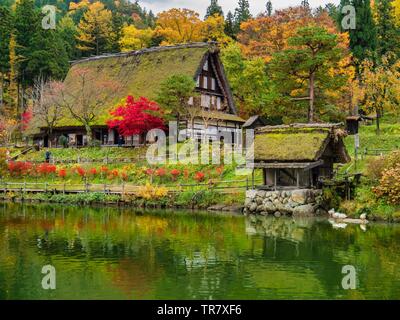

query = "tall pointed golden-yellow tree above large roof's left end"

[{"left": 77, "top": 2, "right": 113, "bottom": 55}]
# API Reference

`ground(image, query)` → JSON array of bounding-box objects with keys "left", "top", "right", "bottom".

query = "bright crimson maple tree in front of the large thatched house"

[{"left": 107, "top": 96, "right": 165, "bottom": 137}]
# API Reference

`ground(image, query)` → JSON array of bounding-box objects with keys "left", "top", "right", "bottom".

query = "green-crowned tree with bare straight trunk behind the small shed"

[{"left": 270, "top": 26, "right": 350, "bottom": 122}]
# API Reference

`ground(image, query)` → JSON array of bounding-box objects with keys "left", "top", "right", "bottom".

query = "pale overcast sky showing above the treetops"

[{"left": 139, "top": 0, "right": 340, "bottom": 16}]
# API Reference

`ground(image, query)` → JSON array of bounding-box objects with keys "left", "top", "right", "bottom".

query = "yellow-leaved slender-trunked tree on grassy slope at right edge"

[{"left": 361, "top": 56, "right": 400, "bottom": 134}]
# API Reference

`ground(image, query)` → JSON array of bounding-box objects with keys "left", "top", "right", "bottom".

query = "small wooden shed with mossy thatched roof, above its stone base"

[{"left": 248, "top": 124, "right": 350, "bottom": 189}]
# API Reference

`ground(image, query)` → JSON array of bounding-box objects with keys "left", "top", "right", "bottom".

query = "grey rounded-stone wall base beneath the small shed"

[{"left": 244, "top": 189, "right": 325, "bottom": 216}]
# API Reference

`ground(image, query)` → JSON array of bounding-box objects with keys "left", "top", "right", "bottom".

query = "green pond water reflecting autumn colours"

[{"left": 0, "top": 204, "right": 400, "bottom": 299}]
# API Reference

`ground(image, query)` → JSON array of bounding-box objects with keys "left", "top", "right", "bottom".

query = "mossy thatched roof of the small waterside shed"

[{"left": 254, "top": 124, "right": 350, "bottom": 163}]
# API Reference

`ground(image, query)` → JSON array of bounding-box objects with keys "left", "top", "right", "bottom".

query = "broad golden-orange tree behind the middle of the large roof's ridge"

[{"left": 155, "top": 8, "right": 203, "bottom": 45}]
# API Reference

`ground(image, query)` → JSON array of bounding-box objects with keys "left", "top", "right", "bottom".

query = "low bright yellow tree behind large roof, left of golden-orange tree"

[{"left": 120, "top": 25, "right": 154, "bottom": 51}]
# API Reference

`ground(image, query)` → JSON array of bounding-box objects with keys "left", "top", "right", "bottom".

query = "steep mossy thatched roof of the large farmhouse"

[{"left": 58, "top": 43, "right": 236, "bottom": 127}]
